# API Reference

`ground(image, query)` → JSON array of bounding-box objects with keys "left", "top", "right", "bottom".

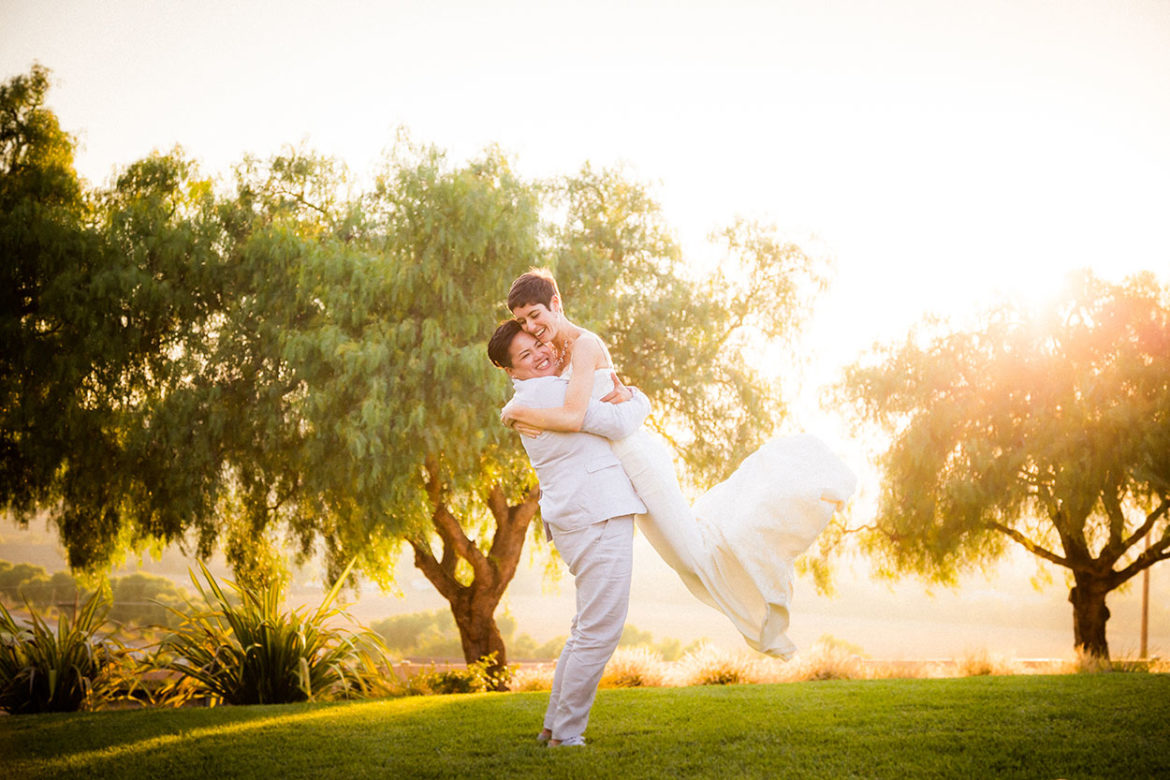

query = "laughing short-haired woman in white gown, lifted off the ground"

[{"left": 502, "top": 270, "right": 856, "bottom": 658}]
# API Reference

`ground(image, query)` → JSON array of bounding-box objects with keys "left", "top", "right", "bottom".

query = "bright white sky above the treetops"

[{"left": 0, "top": 0, "right": 1170, "bottom": 659}]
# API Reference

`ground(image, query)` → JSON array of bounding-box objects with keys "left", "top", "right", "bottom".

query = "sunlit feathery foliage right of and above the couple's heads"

[{"left": 552, "top": 165, "right": 827, "bottom": 483}]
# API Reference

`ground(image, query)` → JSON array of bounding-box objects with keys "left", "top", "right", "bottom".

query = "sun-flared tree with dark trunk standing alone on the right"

[{"left": 844, "top": 274, "right": 1170, "bottom": 660}]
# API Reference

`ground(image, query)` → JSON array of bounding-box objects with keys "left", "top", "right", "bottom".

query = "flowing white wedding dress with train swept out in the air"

[{"left": 593, "top": 371, "right": 856, "bottom": 658}]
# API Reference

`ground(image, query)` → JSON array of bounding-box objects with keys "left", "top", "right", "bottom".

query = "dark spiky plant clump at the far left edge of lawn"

[{"left": 0, "top": 592, "right": 128, "bottom": 715}]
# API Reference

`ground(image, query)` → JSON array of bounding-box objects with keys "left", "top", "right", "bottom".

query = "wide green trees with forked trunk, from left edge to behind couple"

[{"left": 0, "top": 74, "right": 823, "bottom": 687}]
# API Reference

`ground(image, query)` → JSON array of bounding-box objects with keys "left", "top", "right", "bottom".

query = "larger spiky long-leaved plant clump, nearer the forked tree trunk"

[{"left": 159, "top": 562, "right": 390, "bottom": 704}]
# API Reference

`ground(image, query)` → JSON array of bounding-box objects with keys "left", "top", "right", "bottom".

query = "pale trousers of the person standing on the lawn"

[{"left": 544, "top": 515, "right": 634, "bottom": 740}]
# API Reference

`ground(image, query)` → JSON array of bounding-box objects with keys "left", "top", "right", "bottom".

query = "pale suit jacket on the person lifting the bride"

[{"left": 510, "top": 377, "right": 651, "bottom": 531}]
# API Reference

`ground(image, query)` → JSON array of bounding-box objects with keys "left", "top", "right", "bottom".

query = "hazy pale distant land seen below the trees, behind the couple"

[{"left": 0, "top": 519, "right": 1170, "bottom": 661}]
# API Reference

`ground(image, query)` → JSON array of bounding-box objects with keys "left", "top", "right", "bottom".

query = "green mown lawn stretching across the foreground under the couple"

[{"left": 0, "top": 674, "right": 1170, "bottom": 780}]
